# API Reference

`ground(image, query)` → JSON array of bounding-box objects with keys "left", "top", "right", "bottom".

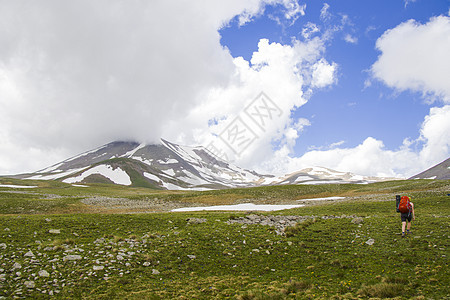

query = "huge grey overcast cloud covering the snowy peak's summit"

[{"left": 0, "top": 0, "right": 314, "bottom": 174}]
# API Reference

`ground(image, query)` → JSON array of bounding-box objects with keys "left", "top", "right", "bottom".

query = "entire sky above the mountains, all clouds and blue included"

[{"left": 0, "top": 0, "right": 450, "bottom": 177}]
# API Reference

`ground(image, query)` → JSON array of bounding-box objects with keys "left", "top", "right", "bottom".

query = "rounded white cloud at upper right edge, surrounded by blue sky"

[{"left": 372, "top": 16, "right": 450, "bottom": 103}]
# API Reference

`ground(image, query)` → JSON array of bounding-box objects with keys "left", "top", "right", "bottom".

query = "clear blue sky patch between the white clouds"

[{"left": 220, "top": 0, "right": 449, "bottom": 155}]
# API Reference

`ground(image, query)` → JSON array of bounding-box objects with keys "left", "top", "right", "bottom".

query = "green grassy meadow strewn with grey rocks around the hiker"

[{"left": 0, "top": 178, "right": 450, "bottom": 299}]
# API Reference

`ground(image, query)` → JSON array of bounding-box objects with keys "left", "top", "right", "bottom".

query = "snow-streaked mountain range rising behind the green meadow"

[{"left": 16, "top": 140, "right": 390, "bottom": 190}]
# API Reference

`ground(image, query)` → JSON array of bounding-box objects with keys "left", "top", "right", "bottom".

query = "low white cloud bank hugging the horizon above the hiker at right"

[{"left": 276, "top": 105, "right": 450, "bottom": 178}]
